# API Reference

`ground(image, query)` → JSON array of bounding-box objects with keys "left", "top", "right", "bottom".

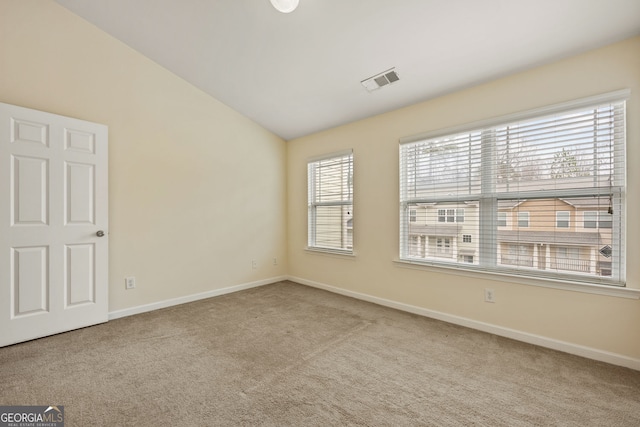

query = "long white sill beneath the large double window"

[{"left": 393, "top": 259, "right": 640, "bottom": 299}]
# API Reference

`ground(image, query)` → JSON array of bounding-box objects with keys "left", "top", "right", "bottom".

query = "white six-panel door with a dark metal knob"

[{"left": 0, "top": 103, "right": 108, "bottom": 346}]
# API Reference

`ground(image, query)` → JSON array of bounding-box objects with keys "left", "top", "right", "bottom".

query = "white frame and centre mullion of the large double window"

[{"left": 398, "top": 90, "right": 630, "bottom": 289}]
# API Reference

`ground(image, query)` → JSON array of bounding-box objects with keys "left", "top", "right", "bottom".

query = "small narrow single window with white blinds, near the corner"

[{"left": 307, "top": 151, "right": 353, "bottom": 253}]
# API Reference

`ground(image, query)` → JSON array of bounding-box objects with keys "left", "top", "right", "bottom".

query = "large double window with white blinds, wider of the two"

[{"left": 400, "top": 91, "right": 628, "bottom": 285}]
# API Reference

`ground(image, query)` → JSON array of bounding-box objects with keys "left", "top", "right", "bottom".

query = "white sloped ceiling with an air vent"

[{"left": 57, "top": 0, "right": 640, "bottom": 140}]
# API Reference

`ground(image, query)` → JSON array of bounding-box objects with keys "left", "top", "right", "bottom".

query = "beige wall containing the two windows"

[{"left": 288, "top": 37, "right": 640, "bottom": 359}]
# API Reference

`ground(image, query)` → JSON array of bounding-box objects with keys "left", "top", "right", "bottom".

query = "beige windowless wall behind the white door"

[{"left": 0, "top": 0, "right": 286, "bottom": 311}]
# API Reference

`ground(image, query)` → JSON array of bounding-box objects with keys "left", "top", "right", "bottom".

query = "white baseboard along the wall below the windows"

[{"left": 288, "top": 276, "right": 640, "bottom": 371}]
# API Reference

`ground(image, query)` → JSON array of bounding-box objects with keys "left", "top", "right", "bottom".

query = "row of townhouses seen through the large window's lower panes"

[{"left": 409, "top": 198, "right": 612, "bottom": 276}]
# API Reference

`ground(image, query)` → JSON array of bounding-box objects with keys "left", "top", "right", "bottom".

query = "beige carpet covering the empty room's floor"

[{"left": 0, "top": 282, "right": 640, "bottom": 426}]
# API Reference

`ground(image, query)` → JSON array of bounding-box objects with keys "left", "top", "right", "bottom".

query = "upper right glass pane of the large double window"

[{"left": 495, "top": 105, "right": 621, "bottom": 192}]
